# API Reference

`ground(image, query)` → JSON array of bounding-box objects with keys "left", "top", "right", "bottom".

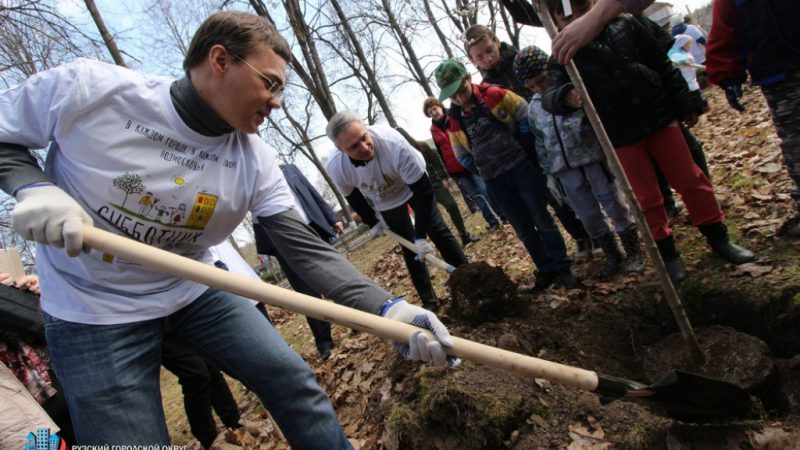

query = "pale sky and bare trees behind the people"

[{"left": 0, "top": 0, "right": 708, "bottom": 271}]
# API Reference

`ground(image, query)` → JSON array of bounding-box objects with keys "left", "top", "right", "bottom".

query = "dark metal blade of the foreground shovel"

[{"left": 594, "top": 370, "right": 754, "bottom": 423}]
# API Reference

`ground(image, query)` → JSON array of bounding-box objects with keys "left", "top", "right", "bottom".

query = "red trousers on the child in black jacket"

[{"left": 615, "top": 123, "right": 725, "bottom": 240}]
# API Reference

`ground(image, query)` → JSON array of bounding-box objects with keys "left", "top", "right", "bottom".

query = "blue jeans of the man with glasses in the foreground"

[{"left": 45, "top": 289, "right": 352, "bottom": 449}]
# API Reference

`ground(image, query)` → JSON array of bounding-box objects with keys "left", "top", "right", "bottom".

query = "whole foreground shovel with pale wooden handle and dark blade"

[{"left": 83, "top": 225, "right": 752, "bottom": 421}]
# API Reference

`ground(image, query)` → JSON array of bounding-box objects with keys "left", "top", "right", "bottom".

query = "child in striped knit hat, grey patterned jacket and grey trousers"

[{"left": 514, "top": 46, "right": 643, "bottom": 279}]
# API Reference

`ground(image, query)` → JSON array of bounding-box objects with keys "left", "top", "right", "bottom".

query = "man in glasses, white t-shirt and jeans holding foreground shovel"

[{"left": 0, "top": 12, "right": 452, "bottom": 449}]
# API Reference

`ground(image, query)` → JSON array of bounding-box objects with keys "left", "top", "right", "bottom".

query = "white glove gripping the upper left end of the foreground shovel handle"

[{"left": 11, "top": 184, "right": 93, "bottom": 256}]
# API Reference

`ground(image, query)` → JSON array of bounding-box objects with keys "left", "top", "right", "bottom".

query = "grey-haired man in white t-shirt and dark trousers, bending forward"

[{"left": 326, "top": 111, "right": 467, "bottom": 311}]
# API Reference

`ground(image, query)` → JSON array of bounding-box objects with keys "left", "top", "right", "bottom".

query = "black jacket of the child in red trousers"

[{"left": 542, "top": 15, "right": 702, "bottom": 147}]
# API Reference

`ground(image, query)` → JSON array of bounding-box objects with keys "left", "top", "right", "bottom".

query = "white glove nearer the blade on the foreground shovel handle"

[{"left": 381, "top": 297, "right": 461, "bottom": 367}]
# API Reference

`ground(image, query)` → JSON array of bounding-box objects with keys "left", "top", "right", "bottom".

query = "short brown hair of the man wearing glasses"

[{"left": 183, "top": 11, "right": 292, "bottom": 70}]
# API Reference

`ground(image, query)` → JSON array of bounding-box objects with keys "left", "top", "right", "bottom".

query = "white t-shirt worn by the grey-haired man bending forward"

[{"left": 328, "top": 125, "right": 425, "bottom": 211}]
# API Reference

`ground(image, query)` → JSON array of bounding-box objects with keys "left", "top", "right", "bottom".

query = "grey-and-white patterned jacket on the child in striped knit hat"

[{"left": 528, "top": 94, "right": 603, "bottom": 174}]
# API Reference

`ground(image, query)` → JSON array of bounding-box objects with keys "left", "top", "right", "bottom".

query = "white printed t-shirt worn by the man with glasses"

[{"left": 0, "top": 59, "right": 294, "bottom": 324}]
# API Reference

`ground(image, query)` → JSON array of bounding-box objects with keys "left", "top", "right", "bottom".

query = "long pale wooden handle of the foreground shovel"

[{"left": 83, "top": 225, "right": 598, "bottom": 391}]
